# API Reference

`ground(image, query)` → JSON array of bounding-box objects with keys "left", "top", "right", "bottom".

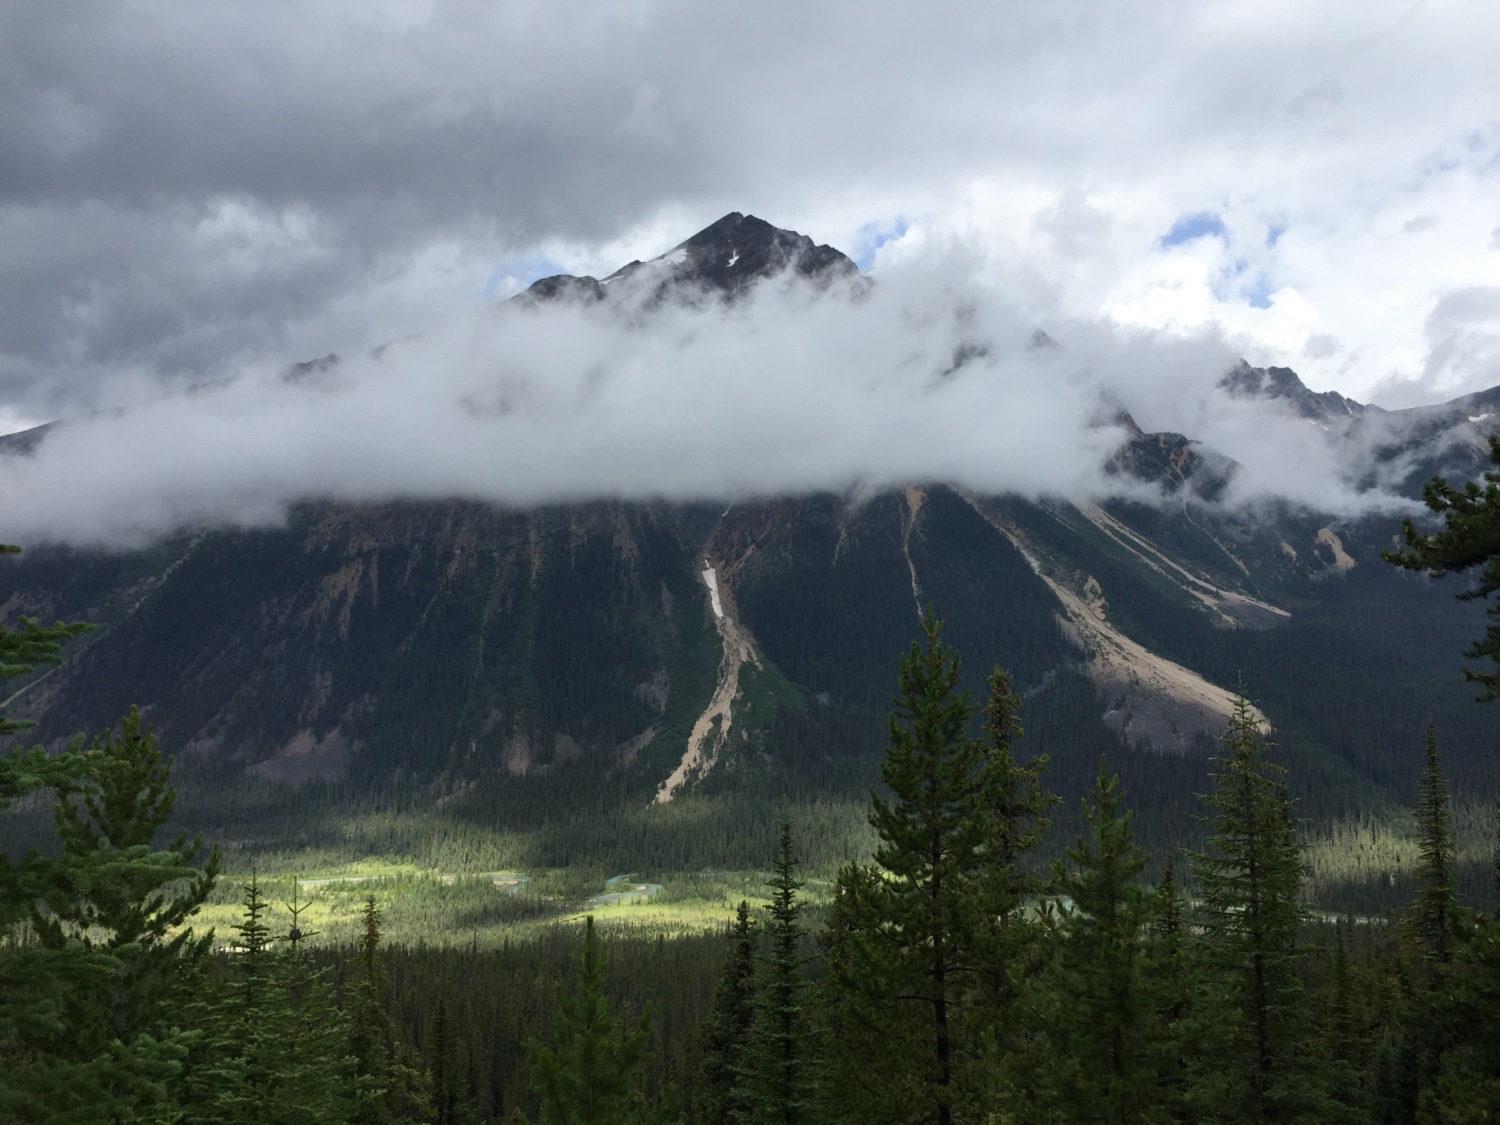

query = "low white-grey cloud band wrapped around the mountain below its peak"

[{"left": 0, "top": 252, "right": 1416, "bottom": 546}]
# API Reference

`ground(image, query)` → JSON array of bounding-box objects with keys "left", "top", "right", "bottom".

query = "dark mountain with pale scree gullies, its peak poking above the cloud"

[{"left": 0, "top": 215, "right": 1500, "bottom": 840}]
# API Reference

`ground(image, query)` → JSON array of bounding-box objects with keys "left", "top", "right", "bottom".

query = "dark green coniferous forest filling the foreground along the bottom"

[{"left": 0, "top": 591, "right": 1500, "bottom": 1125}]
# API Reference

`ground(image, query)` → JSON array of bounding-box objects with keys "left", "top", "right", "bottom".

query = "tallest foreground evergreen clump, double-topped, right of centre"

[{"left": 824, "top": 609, "right": 1049, "bottom": 1125}]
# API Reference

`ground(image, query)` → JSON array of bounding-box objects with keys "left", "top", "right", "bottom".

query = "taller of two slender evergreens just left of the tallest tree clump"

[{"left": 738, "top": 821, "right": 813, "bottom": 1125}]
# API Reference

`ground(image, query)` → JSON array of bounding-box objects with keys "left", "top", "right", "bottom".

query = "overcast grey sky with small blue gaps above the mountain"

[{"left": 0, "top": 0, "right": 1500, "bottom": 546}]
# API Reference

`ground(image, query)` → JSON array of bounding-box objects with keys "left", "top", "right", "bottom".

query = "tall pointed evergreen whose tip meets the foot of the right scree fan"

[{"left": 1194, "top": 695, "right": 1340, "bottom": 1122}]
